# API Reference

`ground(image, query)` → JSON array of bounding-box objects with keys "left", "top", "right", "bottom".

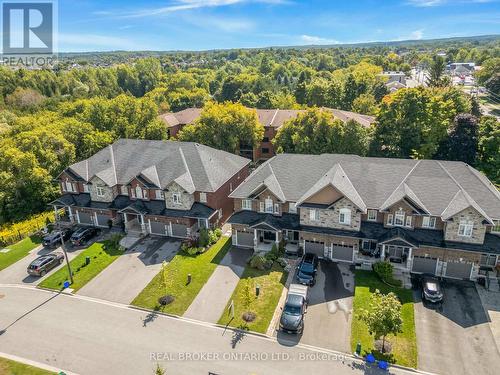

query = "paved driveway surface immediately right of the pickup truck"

[{"left": 277, "top": 260, "right": 354, "bottom": 353}]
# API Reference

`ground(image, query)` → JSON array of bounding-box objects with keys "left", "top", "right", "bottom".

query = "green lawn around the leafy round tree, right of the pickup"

[{"left": 351, "top": 270, "right": 417, "bottom": 368}]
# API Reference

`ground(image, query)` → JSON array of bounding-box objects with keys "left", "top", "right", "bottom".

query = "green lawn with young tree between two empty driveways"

[{"left": 132, "top": 237, "right": 231, "bottom": 315}]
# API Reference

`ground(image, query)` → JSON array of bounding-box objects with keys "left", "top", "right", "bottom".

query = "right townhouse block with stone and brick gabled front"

[{"left": 228, "top": 154, "right": 500, "bottom": 279}]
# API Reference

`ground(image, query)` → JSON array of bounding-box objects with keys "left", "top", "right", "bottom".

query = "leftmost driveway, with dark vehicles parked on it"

[{"left": 0, "top": 246, "right": 84, "bottom": 285}]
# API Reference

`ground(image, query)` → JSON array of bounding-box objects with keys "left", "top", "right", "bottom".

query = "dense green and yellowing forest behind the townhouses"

[{"left": 0, "top": 37, "right": 500, "bottom": 223}]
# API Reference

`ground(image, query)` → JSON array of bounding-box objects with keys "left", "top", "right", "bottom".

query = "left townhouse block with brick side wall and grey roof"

[{"left": 51, "top": 139, "right": 250, "bottom": 238}]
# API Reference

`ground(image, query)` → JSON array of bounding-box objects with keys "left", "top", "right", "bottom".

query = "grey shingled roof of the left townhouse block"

[{"left": 68, "top": 139, "right": 250, "bottom": 193}]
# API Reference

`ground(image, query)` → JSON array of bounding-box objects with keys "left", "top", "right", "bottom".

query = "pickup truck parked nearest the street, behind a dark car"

[{"left": 280, "top": 284, "right": 308, "bottom": 334}]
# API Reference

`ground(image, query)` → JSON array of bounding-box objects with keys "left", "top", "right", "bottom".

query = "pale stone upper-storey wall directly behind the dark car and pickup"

[{"left": 300, "top": 198, "right": 361, "bottom": 231}]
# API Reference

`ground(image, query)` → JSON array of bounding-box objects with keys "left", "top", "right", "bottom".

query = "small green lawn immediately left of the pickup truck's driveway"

[{"left": 219, "top": 263, "right": 288, "bottom": 333}]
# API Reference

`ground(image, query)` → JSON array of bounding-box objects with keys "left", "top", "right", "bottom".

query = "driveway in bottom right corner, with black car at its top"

[{"left": 415, "top": 280, "right": 500, "bottom": 375}]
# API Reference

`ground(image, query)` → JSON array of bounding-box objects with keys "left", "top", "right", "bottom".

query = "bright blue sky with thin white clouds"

[{"left": 52, "top": 0, "right": 500, "bottom": 52}]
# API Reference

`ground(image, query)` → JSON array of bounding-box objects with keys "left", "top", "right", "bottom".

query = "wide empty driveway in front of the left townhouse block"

[{"left": 78, "top": 236, "right": 181, "bottom": 304}]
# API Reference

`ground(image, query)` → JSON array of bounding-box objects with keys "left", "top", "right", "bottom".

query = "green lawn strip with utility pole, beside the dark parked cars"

[{"left": 40, "top": 240, "right": 123, "bottom": 292}]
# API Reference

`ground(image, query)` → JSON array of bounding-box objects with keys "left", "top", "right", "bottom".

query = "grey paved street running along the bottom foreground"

[{"left": 0, "top": 286, "right": 414, "bottom": 375}]
